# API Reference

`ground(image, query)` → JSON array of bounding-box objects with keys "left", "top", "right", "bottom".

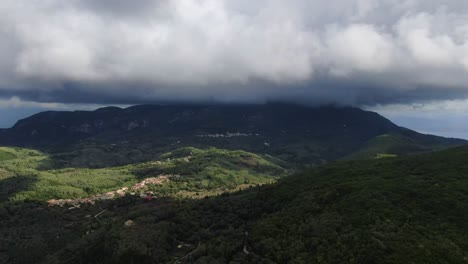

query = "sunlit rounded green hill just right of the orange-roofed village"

[{"left": 139, "top": 148, "right": 286, "bottom": 196}]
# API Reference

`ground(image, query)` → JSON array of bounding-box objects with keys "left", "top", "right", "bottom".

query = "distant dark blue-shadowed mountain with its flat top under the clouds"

[{"left": 0, "top": 104, "right": 466, "bottom": 167}]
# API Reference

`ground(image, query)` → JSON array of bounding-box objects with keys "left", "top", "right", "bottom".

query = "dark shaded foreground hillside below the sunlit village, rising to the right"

[{"left": 0, "top": 144, "right": 468, "bottom": 264}]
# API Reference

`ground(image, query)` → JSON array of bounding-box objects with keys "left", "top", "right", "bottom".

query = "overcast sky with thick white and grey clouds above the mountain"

[{"left": 0, "top": 0, "right": 468, "bottom": 138}]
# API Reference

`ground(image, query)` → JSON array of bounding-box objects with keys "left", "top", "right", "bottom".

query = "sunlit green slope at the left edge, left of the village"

[{"left": 0, "top": 148, "right": 136, "bottom": 201}]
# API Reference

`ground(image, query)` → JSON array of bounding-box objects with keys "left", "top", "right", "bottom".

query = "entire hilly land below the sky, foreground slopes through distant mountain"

[{"left": 0, "top": 104, "right": 468, "bottom": 263}]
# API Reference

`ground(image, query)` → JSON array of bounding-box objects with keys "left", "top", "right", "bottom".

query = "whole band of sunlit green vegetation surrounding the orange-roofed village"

[{"left": 0, "top": 148, "right": 286, "bottom": 201}]
